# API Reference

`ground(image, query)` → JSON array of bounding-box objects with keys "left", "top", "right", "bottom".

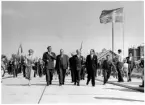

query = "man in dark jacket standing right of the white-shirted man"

[{"left": 126, "top": 53, "right": 135, "bottom": 82}]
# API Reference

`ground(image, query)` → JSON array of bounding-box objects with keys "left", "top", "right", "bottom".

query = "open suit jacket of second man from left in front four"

[{"left": 55, "top": 54, "right": 69, "bottom": 70}]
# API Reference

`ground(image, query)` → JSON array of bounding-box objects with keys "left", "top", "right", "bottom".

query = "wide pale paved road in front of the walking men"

[{"left": 2, "top": 76, "right": 144, "bottom": 104}]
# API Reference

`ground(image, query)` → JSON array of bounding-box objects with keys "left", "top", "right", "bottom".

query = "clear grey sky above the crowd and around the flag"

[{"left": 2, "top": 1, "right": 144, "bottom": 57}]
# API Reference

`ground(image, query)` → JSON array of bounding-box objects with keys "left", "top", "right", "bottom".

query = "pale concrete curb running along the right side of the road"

[{"left": 96, "top": 79, "right": 144, "bottom": 92}]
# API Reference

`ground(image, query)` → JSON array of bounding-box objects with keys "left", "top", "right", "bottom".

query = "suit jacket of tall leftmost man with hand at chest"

[{"left": 43, "top": 52, "right": 56, "bottom": 69}]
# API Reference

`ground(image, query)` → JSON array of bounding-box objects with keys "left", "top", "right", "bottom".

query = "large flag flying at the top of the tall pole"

[{"left": 100, "top": 8, "right": 123, "bottom": 24}]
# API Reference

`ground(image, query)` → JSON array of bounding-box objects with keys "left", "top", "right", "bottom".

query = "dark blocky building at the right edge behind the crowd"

[{"left": 128, "top": 46, "right": 144, "bottom": 61}]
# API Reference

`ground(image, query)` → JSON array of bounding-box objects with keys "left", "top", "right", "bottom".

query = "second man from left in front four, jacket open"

[{"left": 55, "top": 49, "right": 69, "bottom": 86}]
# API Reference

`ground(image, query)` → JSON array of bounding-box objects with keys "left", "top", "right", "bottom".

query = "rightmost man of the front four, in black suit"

[{"left": 86, "top": 49, "right": 98, "bottom": 86}]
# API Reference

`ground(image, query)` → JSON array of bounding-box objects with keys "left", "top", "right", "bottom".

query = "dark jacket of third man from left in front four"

[{"left": 73, "top": 55, "right": 83, "bottom": 70}]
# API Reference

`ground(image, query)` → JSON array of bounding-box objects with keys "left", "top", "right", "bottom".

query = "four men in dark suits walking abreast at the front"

[{"left": 43, "top": 46, "right": 97, "bottom": 86}]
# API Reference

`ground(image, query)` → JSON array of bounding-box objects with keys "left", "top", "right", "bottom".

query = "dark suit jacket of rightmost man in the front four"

[{"left": 86, "top": 55, "right": 98, "bottom": 71}]
